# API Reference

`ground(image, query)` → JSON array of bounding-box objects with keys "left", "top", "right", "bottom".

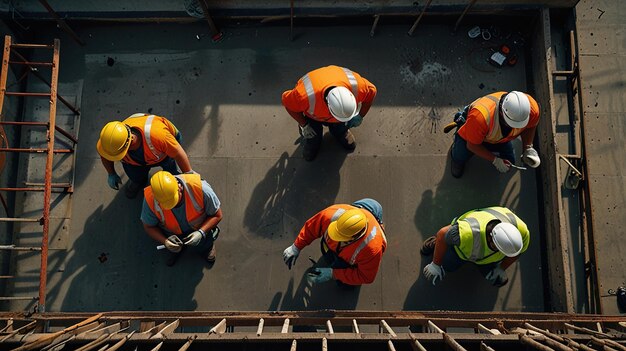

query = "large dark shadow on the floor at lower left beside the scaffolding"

[{"left": 48, "top": 189, "right": 206, "bottom": 311}]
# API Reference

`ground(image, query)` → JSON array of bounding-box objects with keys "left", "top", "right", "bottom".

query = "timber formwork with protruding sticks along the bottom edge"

[{"left": 0, "top": 310, "right": 626, "bottom": 351}]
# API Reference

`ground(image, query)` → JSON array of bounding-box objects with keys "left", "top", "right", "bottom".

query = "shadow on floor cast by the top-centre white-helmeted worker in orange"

[{"left": 244, "top": 132, "right": 347, "bottom": 239}]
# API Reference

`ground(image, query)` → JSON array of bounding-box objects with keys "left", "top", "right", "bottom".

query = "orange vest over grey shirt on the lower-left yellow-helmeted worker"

[{"left": 143, "top": 174, "right": 207, "bottom": 235}]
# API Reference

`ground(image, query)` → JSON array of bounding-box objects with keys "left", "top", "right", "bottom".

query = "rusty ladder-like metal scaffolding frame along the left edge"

[{"left": 0, "top": 35, "right": 80, "bottom": 312}]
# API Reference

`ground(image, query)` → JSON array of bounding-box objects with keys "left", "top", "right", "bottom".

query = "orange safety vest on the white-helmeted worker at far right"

[{"left": 470, "top": 91, "right": 532, "bottom": 144}]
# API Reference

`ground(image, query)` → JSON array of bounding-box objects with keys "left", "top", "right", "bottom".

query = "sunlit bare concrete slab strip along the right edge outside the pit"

[{"left": 576, "top": 0, "right": 626, "bottom": 314}]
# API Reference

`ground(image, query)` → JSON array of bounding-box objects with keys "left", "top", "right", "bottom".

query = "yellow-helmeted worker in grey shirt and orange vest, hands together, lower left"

[{"left": 141, "top": 171, "right": 222, "bottom": 266}]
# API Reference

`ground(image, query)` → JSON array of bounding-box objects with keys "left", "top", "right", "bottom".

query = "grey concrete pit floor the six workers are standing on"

[{"left": 4, "top": 19, "right": 544, "bottom": 311}]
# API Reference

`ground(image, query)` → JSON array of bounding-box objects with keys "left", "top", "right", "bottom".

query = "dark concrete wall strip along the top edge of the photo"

[{"left": 0, "top": 0, "right": 578, "bottom": 18}]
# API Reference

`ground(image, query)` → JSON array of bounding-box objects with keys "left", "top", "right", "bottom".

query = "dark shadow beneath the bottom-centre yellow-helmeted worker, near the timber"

[{"left": 268, "top": 257, "right": 361, "bottom": 311}]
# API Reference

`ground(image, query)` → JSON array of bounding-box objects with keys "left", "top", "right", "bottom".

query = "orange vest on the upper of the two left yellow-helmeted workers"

[{"left": 122, "top": 113, "right": 178, "bottom": 166}]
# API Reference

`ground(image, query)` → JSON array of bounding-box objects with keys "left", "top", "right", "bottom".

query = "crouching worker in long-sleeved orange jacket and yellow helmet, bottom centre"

[{"left": 283, "top": 199, "right": 387, "bottom": 286}]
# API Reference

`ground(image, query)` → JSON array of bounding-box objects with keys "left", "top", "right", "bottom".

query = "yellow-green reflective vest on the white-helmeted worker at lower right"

[{"left": 452, "top": 207, "right": 530, "bottom": 264}]
